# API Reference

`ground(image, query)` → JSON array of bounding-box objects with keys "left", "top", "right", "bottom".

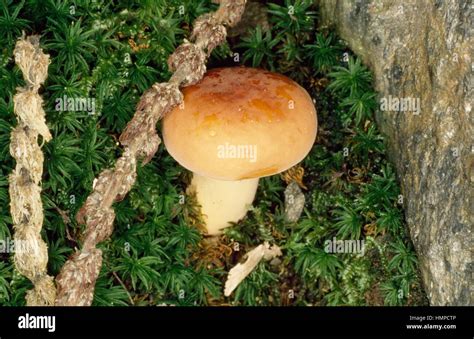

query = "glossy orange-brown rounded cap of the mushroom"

[{"left": 163, "top": 67, "right": 317, "bottom": 180}]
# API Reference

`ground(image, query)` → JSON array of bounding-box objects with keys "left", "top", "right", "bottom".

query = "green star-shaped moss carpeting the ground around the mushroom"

[{"left": 0, "top": 0, "right": 426, "bottom": 305}]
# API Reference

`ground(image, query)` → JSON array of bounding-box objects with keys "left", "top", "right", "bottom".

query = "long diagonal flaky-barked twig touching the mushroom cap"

[{"left": 56, "top": 0, "right": 246, "bottom": 306}]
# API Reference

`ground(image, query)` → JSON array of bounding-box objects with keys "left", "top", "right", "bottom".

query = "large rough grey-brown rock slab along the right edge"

[{"left": 318, "top": 0, "right": 474, "bottom": 305}]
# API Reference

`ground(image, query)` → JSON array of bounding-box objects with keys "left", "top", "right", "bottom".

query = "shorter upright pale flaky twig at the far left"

[{"left": 9, "top": 36, "right": 56, "bottom": 306}]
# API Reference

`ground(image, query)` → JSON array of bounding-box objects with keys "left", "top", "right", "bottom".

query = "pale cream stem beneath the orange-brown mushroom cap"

[{"left": 191, "top": 173, "right": 258, "bottom": 235}]
